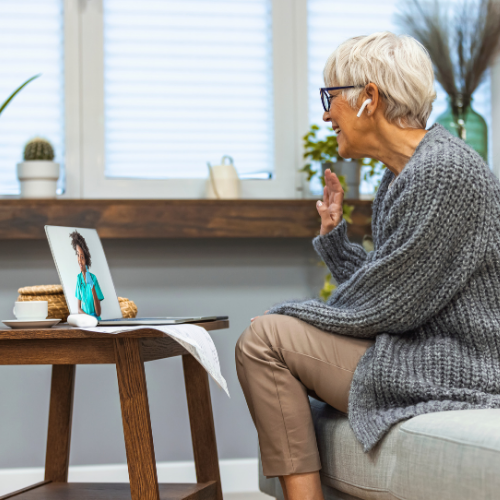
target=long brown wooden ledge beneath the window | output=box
[0,199,372,241]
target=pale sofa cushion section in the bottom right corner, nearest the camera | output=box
[390,410,500,500]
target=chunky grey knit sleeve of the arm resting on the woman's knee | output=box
[269,154,492,338]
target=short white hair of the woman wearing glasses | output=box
[323,31,436,129]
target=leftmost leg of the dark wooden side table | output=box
[45,365,75,483]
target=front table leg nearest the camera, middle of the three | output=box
[115,338,160,500]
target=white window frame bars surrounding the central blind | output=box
[62,0,500,199]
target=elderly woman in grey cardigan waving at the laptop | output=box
[236,32,500,500]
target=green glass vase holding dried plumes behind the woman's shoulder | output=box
[436,96,488,162]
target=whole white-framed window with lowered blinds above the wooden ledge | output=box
[0,0,500,199]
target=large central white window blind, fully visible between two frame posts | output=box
[104,0,274,179]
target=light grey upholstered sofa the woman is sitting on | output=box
[310,398,500,500]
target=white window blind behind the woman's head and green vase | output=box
[308,0,491,194]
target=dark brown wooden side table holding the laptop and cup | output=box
[0,321,229,500]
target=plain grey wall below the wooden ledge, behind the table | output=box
[0,239,324,468]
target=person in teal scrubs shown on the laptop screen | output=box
[69,231,104,320]
